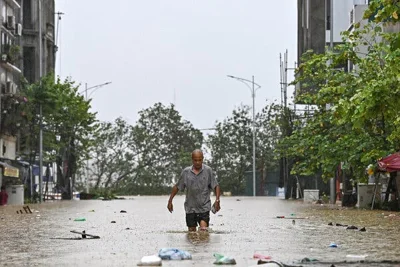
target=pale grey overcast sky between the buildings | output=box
[56,0,297,133]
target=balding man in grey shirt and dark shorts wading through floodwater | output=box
[167,149,221,232]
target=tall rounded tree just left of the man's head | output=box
[131,103,203,193]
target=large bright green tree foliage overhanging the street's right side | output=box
[280,10,400,182]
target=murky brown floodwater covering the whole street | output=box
[0,196,400,267]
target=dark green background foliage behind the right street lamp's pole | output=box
[207,104,281,195]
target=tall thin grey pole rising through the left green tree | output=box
[38,0,43,203]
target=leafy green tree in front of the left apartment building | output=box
[21,74,95,198]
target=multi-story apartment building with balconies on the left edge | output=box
[0,0,56,188]
